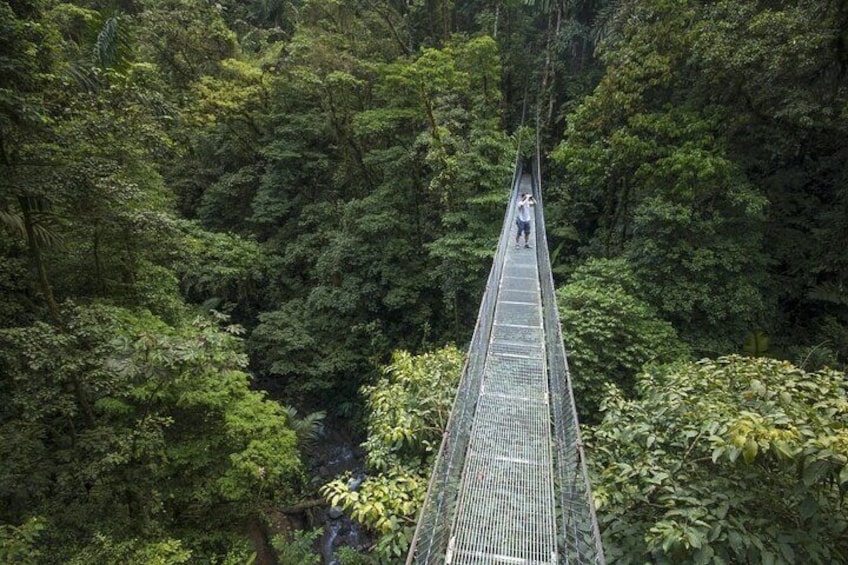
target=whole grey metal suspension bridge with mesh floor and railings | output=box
[406,152,605,565]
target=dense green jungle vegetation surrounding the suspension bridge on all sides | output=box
[0,0,848,565]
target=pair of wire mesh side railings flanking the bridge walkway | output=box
[406,119,605,565]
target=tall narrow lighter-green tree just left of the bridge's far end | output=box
[378,37,514,338]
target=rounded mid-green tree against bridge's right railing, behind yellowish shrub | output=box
[557,259,688,423]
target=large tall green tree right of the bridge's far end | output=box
[553,1,770,351]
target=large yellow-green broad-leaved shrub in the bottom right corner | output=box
[587,357,848,564]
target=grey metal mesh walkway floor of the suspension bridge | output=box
[445,213,557,564]
